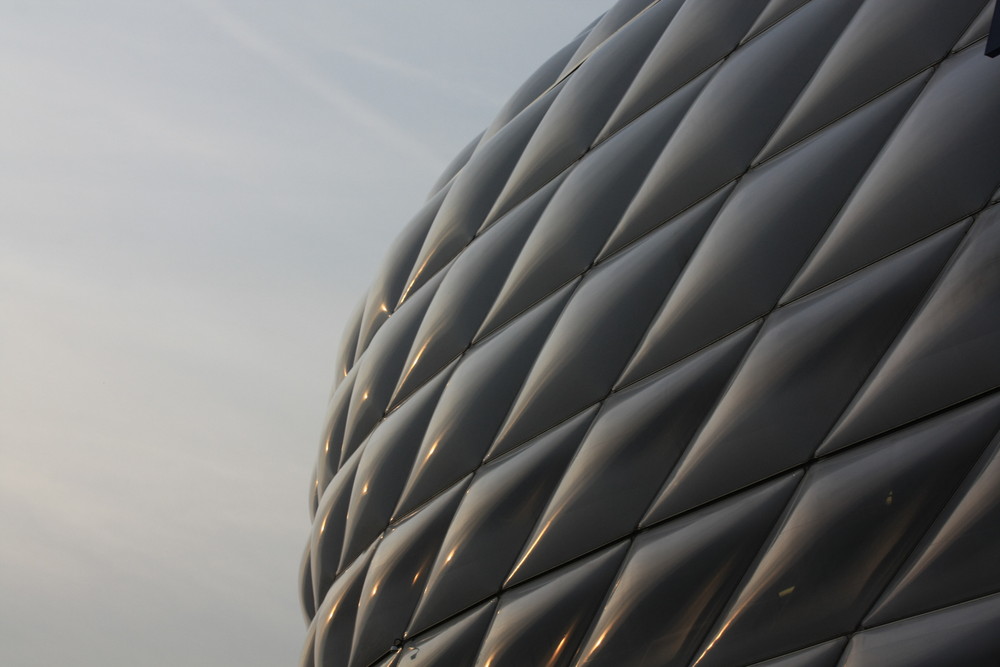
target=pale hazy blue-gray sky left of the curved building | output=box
[0,0,612,667]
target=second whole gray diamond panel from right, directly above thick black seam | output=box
[510,328,756,582]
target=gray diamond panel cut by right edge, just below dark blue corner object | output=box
[784,49,1000,301]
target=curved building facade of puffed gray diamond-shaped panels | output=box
[302,0,1000,667]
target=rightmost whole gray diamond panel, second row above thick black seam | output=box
[625,76,922,386]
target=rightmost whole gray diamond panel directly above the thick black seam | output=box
[650,228,962,520]
